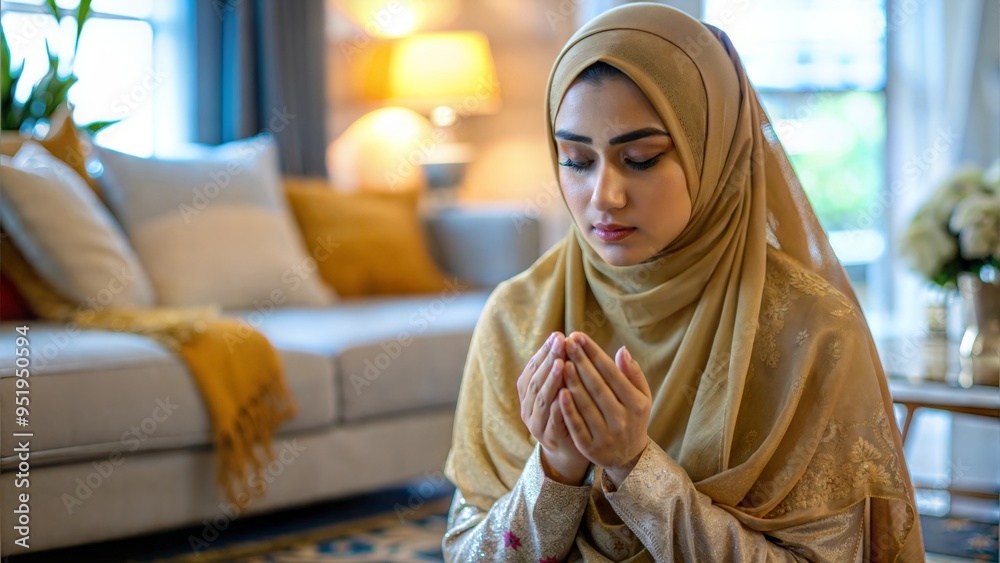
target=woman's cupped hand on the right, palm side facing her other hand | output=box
[559,332,652,486]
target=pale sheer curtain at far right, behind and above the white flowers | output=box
[887,0,1000,337]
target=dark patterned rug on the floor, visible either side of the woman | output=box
[5,479,997,563]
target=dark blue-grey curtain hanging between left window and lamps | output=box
[192,0,327,176]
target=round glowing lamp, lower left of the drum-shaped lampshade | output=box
[327,107,433,192]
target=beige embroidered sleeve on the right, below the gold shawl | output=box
[602,441,866,561]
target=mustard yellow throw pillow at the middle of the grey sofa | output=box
[285,178,446,297]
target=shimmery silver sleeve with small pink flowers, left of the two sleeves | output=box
[442,446,593,563]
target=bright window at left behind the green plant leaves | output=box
[2,0,190,156]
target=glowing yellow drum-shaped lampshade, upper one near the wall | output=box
[387,31,500,120]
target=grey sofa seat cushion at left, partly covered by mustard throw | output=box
[0,322,339,469]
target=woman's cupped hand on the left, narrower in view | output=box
[517,332,590,485]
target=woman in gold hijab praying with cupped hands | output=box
[444,4,923,562]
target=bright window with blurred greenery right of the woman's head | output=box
[704,0,889,321]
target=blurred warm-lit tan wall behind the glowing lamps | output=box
[327,0,701,246]
